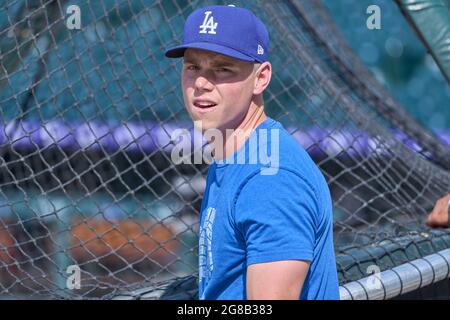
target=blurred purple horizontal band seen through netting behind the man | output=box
[0,121,450,156]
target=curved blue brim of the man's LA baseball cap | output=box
[166,42,257,62]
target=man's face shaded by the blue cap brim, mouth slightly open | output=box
[181,49,257,131]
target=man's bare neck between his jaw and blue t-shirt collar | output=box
[212,103,267,160]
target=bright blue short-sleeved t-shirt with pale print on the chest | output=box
[199,118,339,300]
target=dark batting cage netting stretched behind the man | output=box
[0,0,450,299]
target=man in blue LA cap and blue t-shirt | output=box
[166,6,339,299]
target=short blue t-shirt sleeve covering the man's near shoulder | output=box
[234,169,320,265]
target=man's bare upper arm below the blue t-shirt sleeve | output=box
[246,260,310,300]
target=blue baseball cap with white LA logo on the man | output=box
[166,5,269,63]
